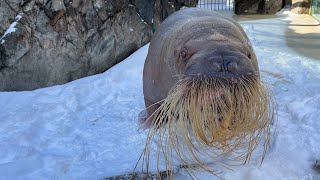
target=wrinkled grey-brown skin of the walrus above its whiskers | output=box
[143,8,259,127]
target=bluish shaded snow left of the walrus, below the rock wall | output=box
[0,46,148,179]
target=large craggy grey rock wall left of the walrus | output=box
[0,0,197,91]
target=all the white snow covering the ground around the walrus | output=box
[0,8,320,180]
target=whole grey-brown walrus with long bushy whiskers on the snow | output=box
[143,8,274,179]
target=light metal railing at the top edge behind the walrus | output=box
[198,0,234,11]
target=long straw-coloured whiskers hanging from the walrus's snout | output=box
[143,75,274,177]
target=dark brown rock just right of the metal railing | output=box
[235,0,283,15]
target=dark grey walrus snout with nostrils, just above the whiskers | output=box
[184,52,255,77]
